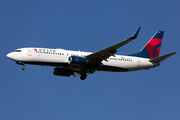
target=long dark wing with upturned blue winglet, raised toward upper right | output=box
[86,27,140,66]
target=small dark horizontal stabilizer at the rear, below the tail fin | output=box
[150,52,177,63]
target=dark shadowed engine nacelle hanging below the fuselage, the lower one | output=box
[53,68,73,77]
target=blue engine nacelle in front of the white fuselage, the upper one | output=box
[68,56,87,64]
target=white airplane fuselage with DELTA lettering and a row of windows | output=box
[7,48,157,72]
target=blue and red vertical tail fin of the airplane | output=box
[131,31,164,59]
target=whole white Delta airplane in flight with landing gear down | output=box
[7,27,177,80]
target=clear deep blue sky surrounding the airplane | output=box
[0,0,180,120]
